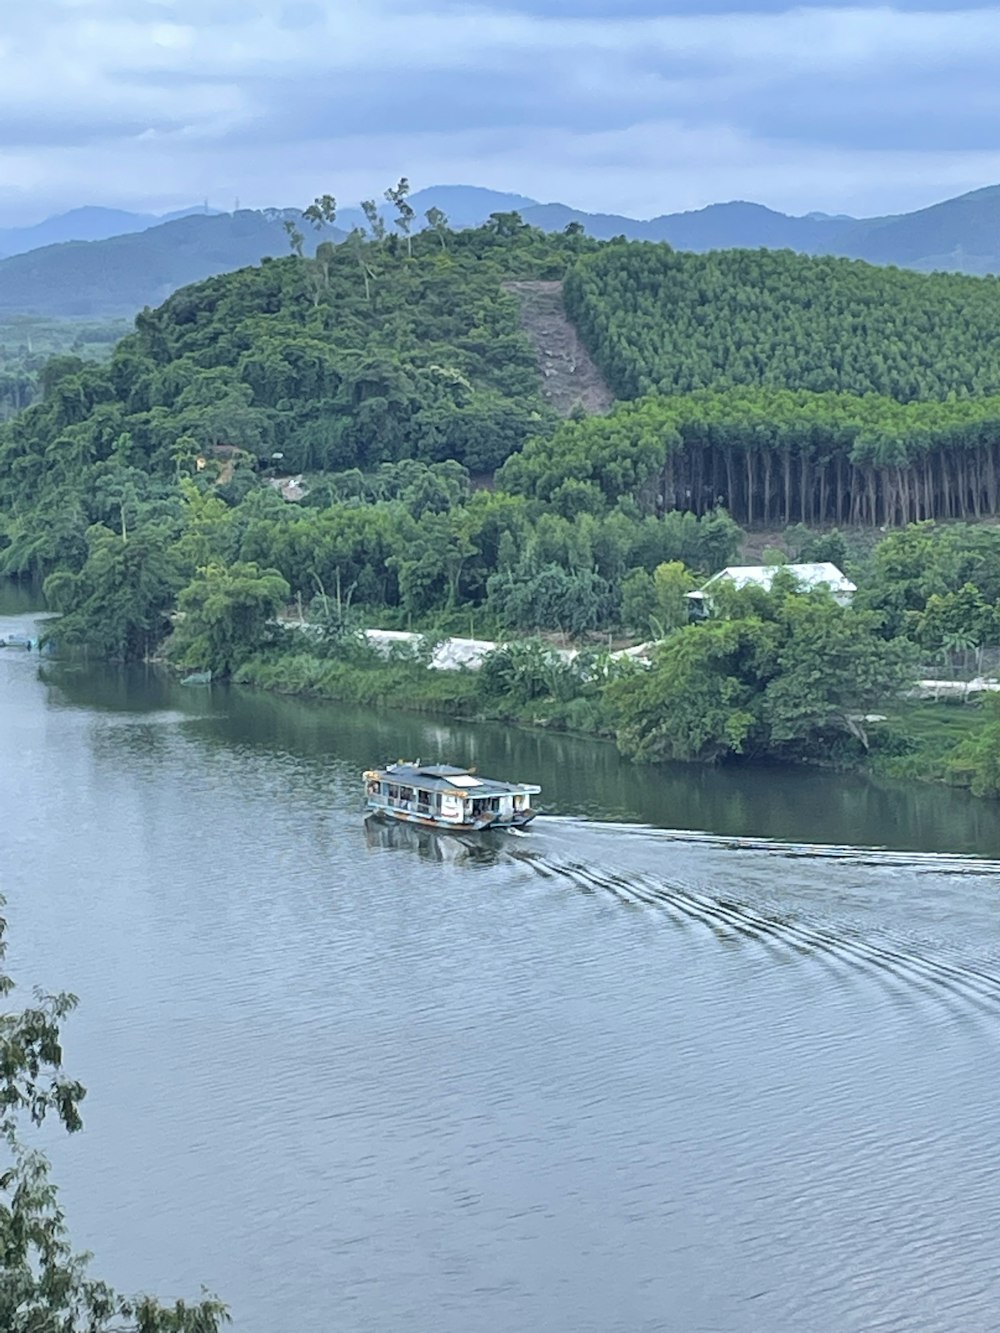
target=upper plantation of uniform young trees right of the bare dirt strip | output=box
[565,244,1000,403]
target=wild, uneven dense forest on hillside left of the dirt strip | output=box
[0,217,592,575]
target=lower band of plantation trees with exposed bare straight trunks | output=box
[500,389,1000,525]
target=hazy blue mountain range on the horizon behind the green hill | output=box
[0,185,1000,317]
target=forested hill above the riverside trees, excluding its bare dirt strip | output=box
[9,213,1000,589]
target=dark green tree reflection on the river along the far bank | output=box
[31,663,1000,856]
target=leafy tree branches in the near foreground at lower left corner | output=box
[0,898,229,1333]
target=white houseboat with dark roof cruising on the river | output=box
[364,760,541,833]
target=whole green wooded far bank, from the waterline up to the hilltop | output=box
[0,193,1000,796]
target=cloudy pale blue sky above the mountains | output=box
[0,0,1000,225]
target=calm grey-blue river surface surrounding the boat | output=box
[0,616,1000,1333]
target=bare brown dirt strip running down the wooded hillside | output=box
[504,283,615,416]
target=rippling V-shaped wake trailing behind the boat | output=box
[365,817,1000,1013]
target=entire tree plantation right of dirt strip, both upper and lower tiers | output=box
[565,244,1000,525]
